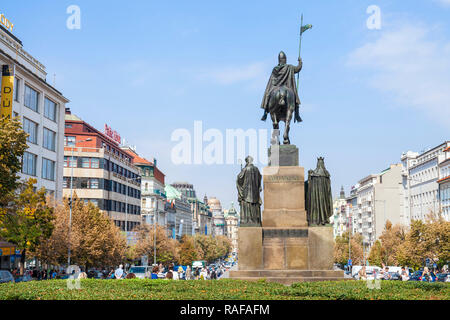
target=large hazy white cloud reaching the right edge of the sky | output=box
[349,26,450,125]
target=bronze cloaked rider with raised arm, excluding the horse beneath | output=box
[261,51,303,122]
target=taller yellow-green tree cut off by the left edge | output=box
[0,117,28,206]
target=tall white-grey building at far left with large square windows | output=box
[0,22,69,199]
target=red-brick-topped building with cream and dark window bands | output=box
[63,109,141,231]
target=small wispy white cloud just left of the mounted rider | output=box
[200,62,269,85]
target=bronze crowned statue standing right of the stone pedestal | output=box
[305,157,333,225]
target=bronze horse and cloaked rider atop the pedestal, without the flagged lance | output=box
[261,51,302,144]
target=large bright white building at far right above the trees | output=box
[402,141,450,225]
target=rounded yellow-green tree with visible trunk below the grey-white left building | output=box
[0,179,54,274]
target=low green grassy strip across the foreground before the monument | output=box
[0,279,450,300]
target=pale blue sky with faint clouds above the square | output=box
[0,0,450,209]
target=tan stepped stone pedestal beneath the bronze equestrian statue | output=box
[230,145,344,284]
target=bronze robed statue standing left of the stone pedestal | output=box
[236,156,262,227]
